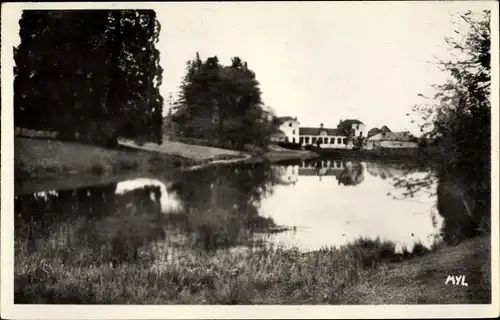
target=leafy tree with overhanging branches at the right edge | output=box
[407,10,491,242]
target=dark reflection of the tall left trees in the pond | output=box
[15,184,163,263]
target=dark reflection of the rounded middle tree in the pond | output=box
[169,164,279,250]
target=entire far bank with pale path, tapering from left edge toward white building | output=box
[14,137,317,195]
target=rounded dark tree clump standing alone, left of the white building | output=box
[172,53,278,149]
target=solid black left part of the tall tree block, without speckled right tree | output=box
[14,10,107,136]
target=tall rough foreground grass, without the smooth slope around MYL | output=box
[15,225,470,304]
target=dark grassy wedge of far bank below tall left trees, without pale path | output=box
[14,138,193,193]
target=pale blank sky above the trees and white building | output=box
[5,1,492,134]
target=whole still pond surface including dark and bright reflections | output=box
[15,160,443,261]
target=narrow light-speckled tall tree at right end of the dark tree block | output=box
[112,10,163,143]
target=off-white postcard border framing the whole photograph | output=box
[0,1,500,319]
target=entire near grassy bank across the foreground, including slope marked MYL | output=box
[14,232,490,304]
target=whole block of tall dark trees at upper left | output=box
[14,10,163,146]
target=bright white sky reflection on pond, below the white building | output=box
[261,160,442,250]
